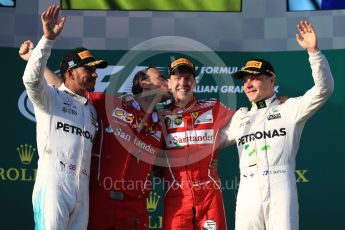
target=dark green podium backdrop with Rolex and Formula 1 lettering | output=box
[0,48,345,229]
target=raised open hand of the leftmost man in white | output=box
[41,5,66,40]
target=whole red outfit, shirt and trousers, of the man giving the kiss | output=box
[88,93,163,230]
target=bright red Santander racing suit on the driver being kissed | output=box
[163,98,235,230]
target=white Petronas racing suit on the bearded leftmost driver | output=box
[23,37,97,230]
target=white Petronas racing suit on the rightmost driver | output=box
[225,51,333,230]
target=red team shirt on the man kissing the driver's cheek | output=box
[89,93,162,198]
